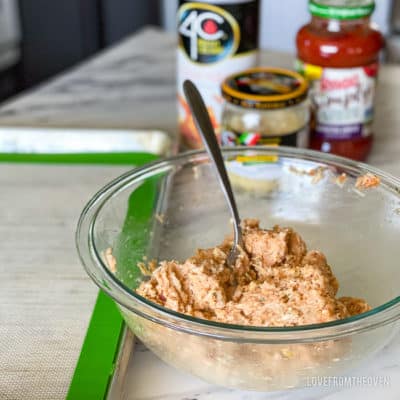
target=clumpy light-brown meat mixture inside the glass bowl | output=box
[137,219,369,326]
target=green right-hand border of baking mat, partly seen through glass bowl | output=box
[67,155,163,400]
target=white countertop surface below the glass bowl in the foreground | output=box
[107,330,400,400]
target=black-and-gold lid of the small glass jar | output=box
[221,68,308,109]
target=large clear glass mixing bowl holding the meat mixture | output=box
[76,147,400,391]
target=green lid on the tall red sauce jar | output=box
[308,0,375,19]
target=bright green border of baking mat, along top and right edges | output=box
[0,132,169,400]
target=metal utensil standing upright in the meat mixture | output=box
[183,80,243,266]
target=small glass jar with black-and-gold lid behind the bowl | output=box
[220,68,309,147]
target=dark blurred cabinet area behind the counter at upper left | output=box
[0,0,160,100]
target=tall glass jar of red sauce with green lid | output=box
[296,0,384,160]
